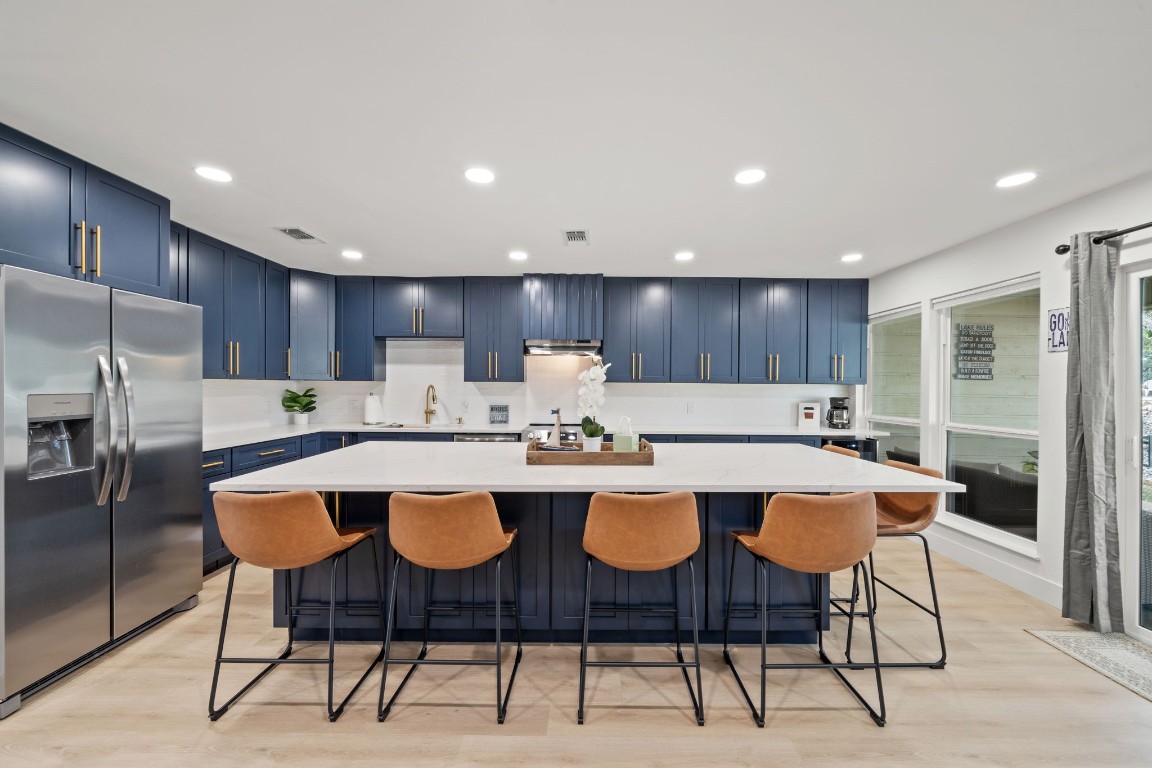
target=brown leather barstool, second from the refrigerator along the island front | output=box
[377,491,524,723]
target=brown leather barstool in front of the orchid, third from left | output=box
[576,491,704,725]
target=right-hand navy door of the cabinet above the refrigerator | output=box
[84,166,169,297]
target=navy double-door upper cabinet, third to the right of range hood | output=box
[740,279,809,383]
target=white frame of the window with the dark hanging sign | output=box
[930,273,1041,562]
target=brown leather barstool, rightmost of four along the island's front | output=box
[723,491,886,728]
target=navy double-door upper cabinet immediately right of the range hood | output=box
[604,277,672,382]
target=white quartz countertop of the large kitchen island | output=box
[211,442,964,493]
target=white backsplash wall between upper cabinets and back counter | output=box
[204,339,863,432]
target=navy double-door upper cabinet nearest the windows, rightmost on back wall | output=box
[808,280,867,385]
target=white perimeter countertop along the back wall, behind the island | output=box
[204,421,888,450]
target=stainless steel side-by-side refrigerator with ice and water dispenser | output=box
[0,266,203,717]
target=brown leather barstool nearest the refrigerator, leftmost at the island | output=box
[209,491,384,721]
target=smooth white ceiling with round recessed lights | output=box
[0,0,1152,276]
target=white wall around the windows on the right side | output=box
[869,169,1152,606]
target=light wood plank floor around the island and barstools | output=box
[0,541,1152,768]
